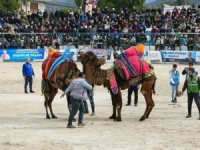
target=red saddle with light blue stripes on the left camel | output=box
[42,49,77,89]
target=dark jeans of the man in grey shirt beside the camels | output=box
[68,97,85,125]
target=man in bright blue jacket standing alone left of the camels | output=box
[22,58,35,93]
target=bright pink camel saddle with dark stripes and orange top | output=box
[114,44,154,85]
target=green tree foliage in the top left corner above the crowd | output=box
[0,0,20,11]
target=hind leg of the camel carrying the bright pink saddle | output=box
[140,81,154,121]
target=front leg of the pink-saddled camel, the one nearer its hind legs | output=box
[115,91,122,121]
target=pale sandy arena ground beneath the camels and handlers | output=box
[0,62,200,150]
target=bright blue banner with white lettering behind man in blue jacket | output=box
[0,49,45,61]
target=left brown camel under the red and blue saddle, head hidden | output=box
[41,61,80,119]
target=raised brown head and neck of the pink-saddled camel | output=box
[79,51,105,86]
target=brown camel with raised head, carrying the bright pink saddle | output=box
[79,51,156,121]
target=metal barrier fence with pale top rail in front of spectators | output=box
[0,32,200,50]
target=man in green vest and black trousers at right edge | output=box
[182,69,200,120]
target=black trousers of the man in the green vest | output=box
[188,93,200,115]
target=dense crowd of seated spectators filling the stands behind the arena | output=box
[0,7,200,50]
